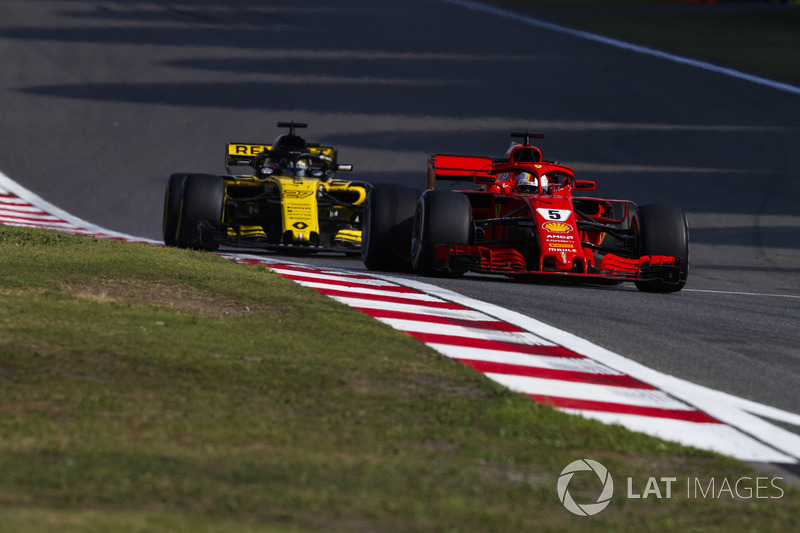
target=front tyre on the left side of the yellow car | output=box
[176,174,225,252]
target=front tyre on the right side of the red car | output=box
[632,204,689,292]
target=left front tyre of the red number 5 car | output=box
[411,190,472,277]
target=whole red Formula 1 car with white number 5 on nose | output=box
[362,131,689,292]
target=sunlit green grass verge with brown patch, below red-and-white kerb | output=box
[0,227,800,533]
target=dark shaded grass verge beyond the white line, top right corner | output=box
[491,0,800,86]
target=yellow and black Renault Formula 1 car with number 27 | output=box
[163,122,370,253]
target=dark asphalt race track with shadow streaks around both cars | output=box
[0,0,800,440]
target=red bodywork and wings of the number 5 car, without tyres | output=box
[428,144,680,281]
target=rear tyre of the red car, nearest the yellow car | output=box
[361,184,420,271]
